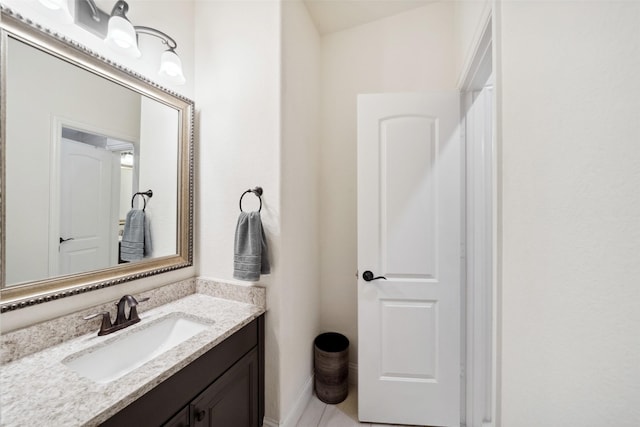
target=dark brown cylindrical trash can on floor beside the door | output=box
[313,332,349,404]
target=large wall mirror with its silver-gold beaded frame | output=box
[0,8,193,312]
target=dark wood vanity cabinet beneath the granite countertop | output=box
[103,315,264,427]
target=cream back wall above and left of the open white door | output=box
[320,3,456,363]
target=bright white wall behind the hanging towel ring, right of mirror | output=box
[195,1,282,420]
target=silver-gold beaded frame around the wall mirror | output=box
[0,5,194,313]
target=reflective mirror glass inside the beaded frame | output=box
[5,38,178,286]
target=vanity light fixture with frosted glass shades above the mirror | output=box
[74,0,186,85]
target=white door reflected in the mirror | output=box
[58,138,120,274]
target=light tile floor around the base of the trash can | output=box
[296,385,424,427]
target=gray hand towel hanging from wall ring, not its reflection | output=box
[233,212,271,282]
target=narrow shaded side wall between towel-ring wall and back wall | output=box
[279,0,320,425]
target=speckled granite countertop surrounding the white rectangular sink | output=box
[0,294,264,426]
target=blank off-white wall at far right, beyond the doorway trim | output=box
[496,1,640,427]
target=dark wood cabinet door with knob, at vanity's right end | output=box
[191,349,262,427]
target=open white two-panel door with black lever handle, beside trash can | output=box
[358,91,462,426]
